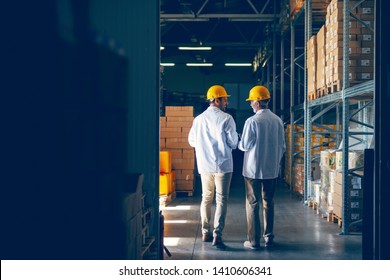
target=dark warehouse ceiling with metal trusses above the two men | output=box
[160,0,280,65]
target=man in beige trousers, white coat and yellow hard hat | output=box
[188,85,238,249]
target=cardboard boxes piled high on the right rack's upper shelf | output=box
[307,0,374,100]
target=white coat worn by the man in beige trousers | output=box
[188,106,238,174]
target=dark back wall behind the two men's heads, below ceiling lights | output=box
[161,65,256,131]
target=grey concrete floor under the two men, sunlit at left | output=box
[161,175,362,260]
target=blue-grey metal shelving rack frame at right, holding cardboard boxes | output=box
[281,0,374,234]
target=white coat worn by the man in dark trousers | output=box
[238,109,286,179]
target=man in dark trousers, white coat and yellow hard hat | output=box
[238,86,286,249]
